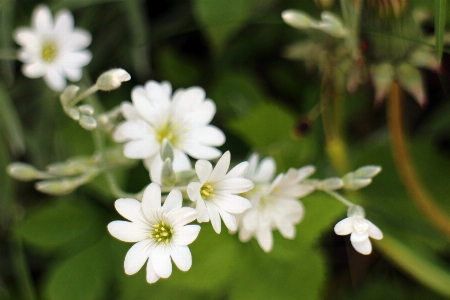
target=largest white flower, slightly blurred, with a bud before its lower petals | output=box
[114,81,225,179]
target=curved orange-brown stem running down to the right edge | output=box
[387,82,450,239]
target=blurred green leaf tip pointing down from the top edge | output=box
[194,0,254,51]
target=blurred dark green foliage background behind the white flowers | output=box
[0,0,450,300]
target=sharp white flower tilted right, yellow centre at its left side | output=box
[187,151,253,233]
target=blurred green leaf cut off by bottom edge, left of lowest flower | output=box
[44,238,110,300]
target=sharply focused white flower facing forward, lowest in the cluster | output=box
[108,183,200,283]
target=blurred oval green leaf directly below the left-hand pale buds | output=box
[18,198,98,251]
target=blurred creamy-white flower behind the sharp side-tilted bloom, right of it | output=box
[239,155,315,252]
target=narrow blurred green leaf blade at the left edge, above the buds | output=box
[0,82,25,155]
